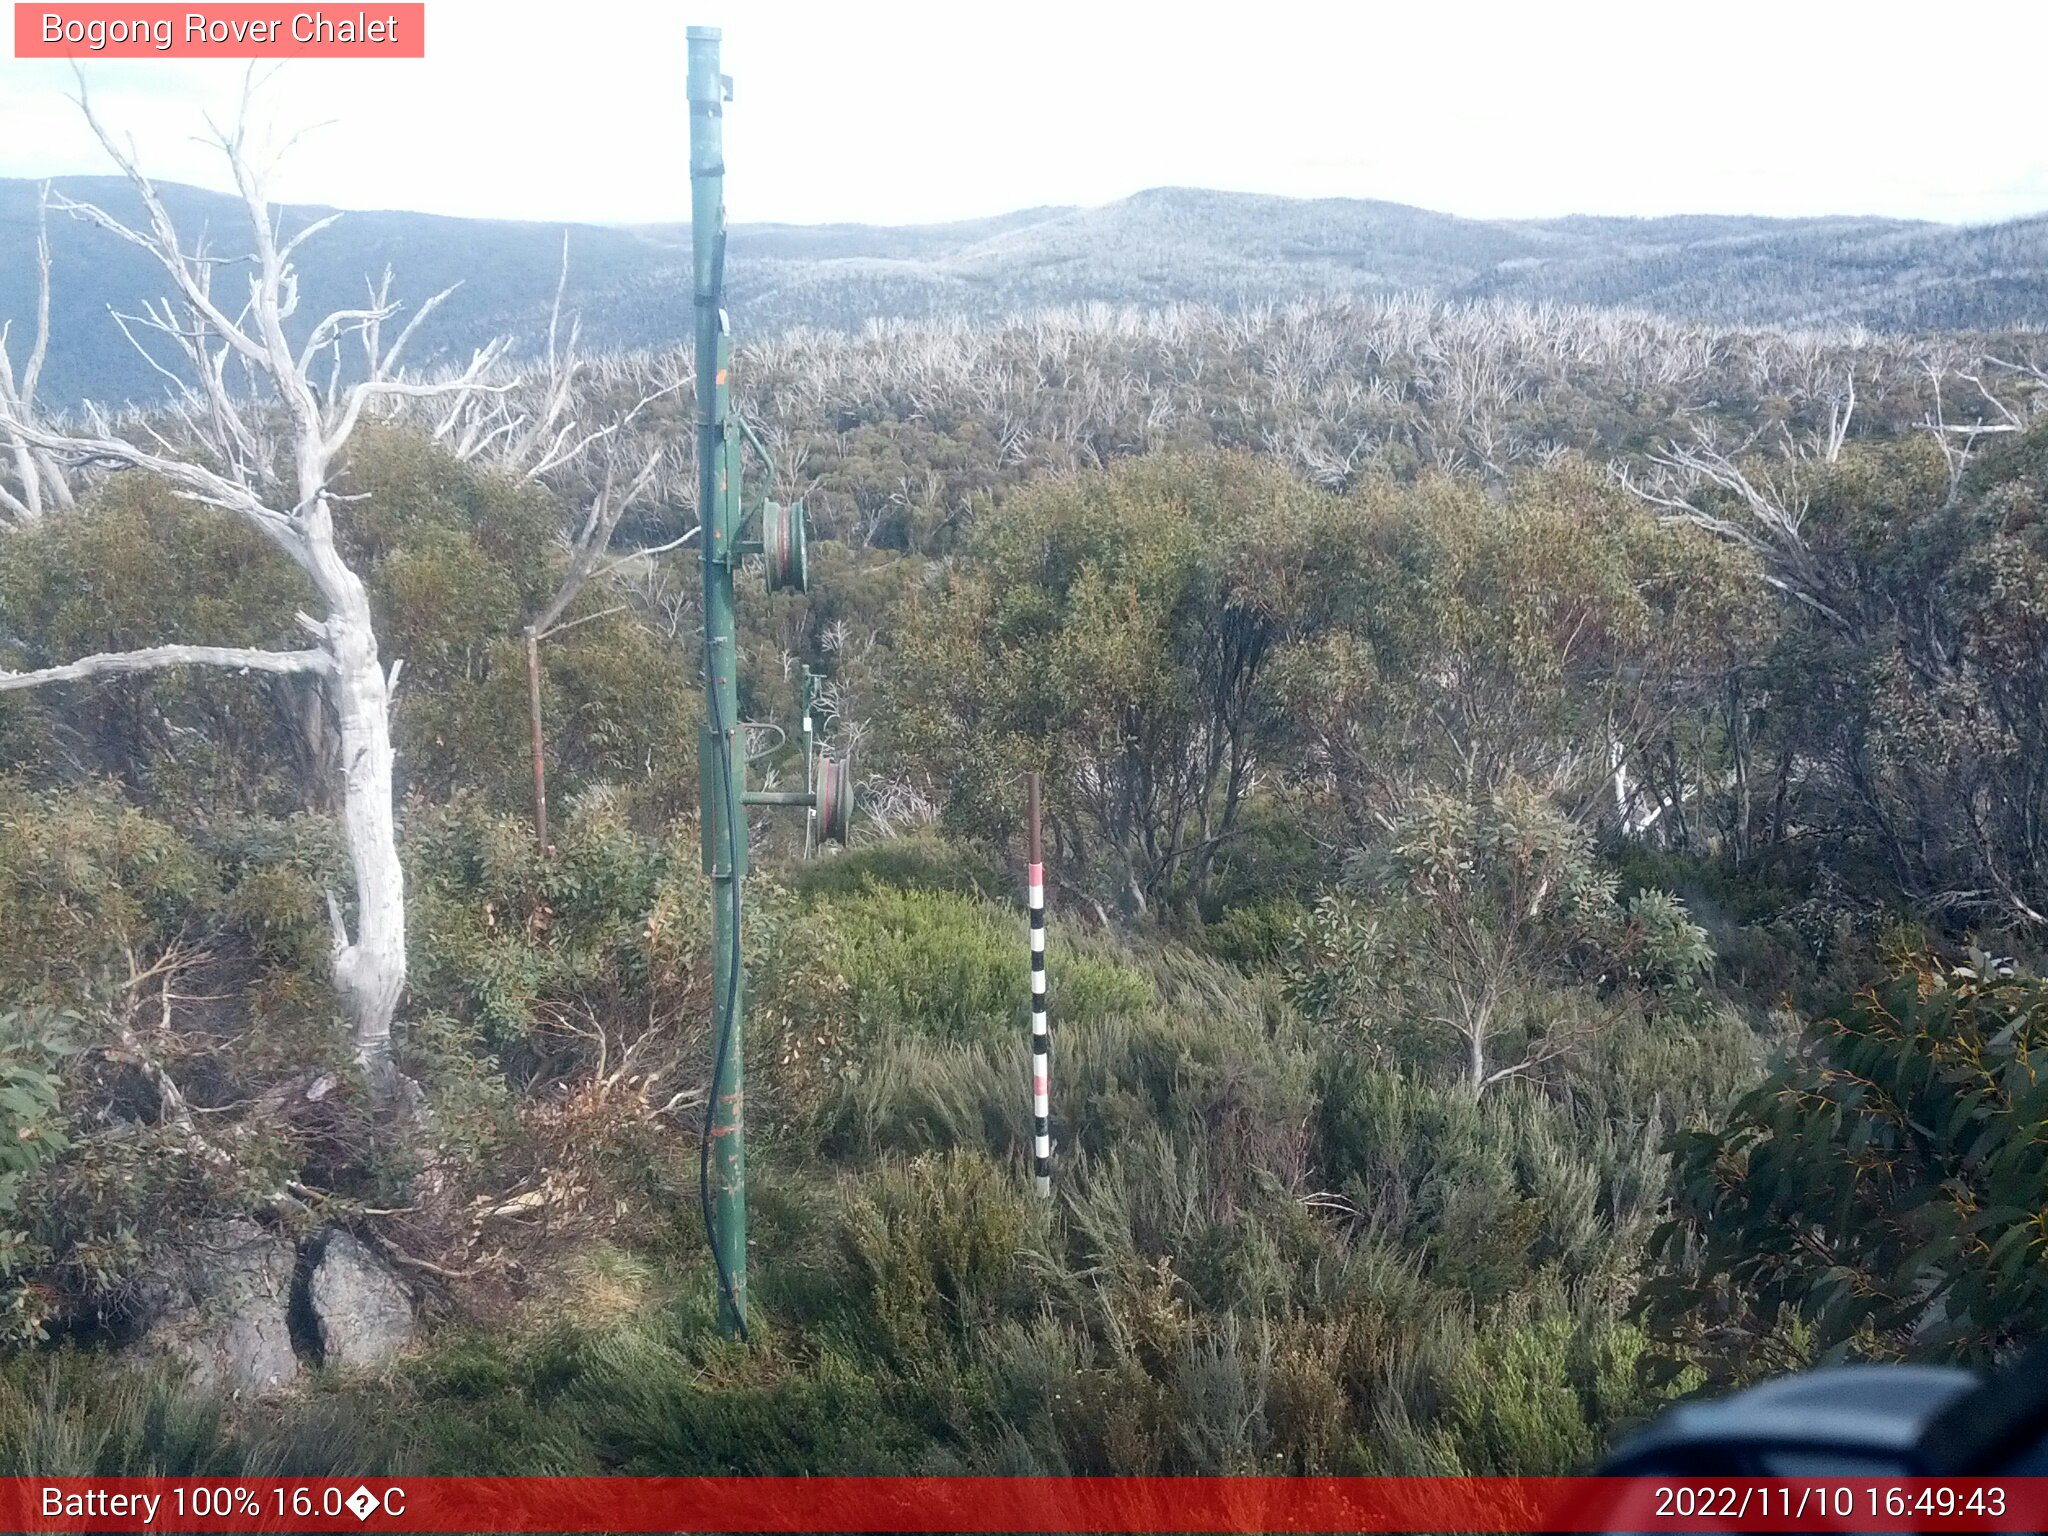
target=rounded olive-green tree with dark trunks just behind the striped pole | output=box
[895,455,1356,911]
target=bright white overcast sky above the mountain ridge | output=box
[0,0,2048,223]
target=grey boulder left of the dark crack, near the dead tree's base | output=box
[141,1217,299,1393]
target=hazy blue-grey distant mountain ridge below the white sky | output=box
[0,178,2048,406]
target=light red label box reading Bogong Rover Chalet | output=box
[14,0,426,59]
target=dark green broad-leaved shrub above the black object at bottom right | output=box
[1645,956,2048,1372]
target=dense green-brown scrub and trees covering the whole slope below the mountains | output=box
[0,294,2048,1473]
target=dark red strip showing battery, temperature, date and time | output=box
[0,1477,2048,1532]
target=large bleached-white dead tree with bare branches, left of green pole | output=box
[0,92,502,1094]
